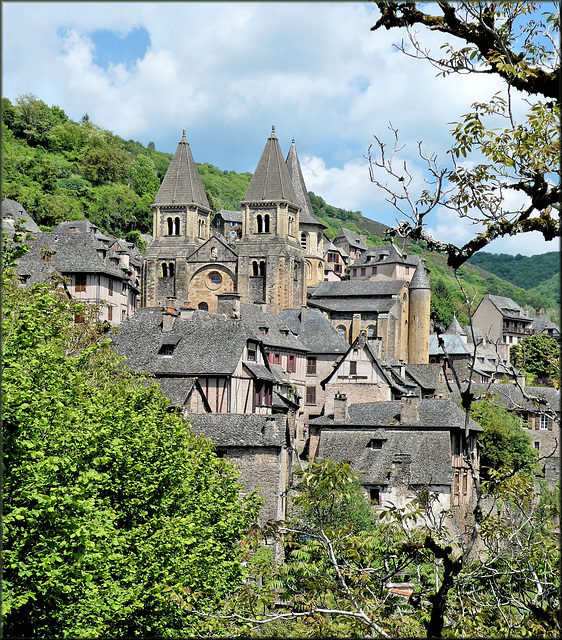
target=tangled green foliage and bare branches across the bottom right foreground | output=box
[176,460,560,638]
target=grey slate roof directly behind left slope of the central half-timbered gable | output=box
[279,309,349,354]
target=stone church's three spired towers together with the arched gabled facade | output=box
[141,127,325,313]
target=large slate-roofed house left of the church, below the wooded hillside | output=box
[16,220,141,325]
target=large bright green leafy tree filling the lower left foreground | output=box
[2,262,258,638]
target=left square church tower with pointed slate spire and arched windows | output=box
[141,130,212,307]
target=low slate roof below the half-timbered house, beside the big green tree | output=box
[189,413,287,448]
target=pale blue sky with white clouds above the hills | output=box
[2,1,559,255]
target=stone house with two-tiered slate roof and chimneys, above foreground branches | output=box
[310,394,482,511]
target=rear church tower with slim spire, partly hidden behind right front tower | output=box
[286,140,327,287]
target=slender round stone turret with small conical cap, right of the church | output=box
[407,260,431,364]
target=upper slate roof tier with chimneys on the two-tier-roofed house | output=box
[310,398,483,431]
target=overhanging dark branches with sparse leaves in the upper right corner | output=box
[368,1,560,268]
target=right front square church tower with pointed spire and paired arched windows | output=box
[236,127,306,313]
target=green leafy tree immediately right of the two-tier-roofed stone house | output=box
[470,398,537,477]
